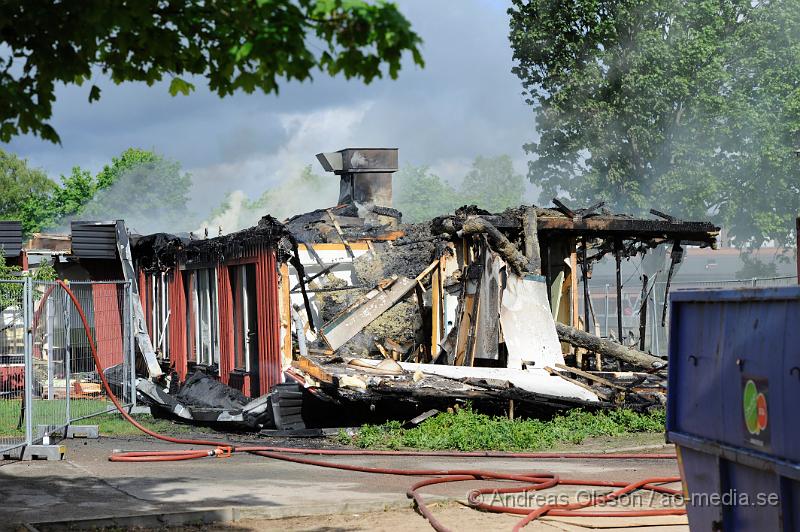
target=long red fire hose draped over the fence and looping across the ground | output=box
[58,280,686,532]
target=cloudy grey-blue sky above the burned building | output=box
[3,0,534,216]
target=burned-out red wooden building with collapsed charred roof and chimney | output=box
[6,148,718,426]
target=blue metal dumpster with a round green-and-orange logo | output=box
[667,287,800,531]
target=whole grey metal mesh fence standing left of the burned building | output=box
[0,278,135,454]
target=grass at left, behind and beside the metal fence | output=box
[0,399,212,438]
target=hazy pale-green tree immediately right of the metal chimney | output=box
[393,165,463,222]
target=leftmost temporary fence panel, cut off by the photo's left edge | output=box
[0,279,29,453]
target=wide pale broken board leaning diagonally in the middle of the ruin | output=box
[320,277,417,351]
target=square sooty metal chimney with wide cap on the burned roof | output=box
[317,148,397,207]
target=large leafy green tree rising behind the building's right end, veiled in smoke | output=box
[509,0,800,246]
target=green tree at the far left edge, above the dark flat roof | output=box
[0,149,57,232]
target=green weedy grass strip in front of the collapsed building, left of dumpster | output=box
[338,406,666,451]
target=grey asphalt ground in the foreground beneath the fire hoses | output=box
[0,435,685,530]
